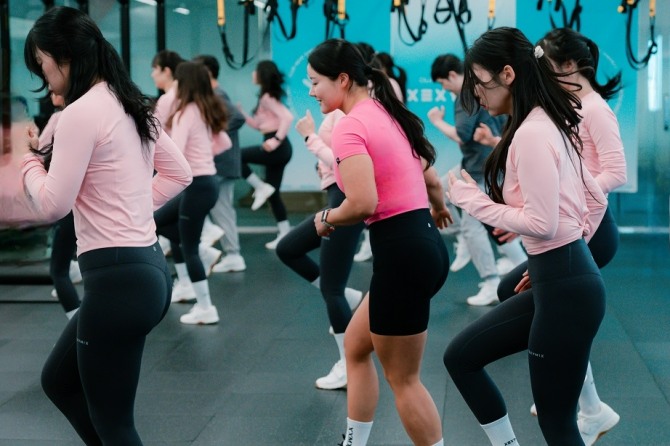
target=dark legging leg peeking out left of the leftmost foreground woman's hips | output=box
[49,212,81,312]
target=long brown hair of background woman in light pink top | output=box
[168,62,228,133]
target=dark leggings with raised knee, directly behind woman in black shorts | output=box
[277,184,365,333]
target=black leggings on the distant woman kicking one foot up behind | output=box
[242,132,293,221]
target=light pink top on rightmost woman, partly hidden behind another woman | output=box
[579,91,626,195]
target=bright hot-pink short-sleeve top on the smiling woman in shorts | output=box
[332,99,428,225]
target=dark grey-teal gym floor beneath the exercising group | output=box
[0,210,670,446]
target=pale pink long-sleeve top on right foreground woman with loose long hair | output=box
[450,107,607,254]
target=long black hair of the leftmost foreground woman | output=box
[23,6,160,158]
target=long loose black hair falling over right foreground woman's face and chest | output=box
[461,27,582,203]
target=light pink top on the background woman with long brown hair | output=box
[171,102,216,177]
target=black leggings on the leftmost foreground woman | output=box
[42,243,172,446]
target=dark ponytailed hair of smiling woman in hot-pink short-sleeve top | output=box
[307,39,436,166]
